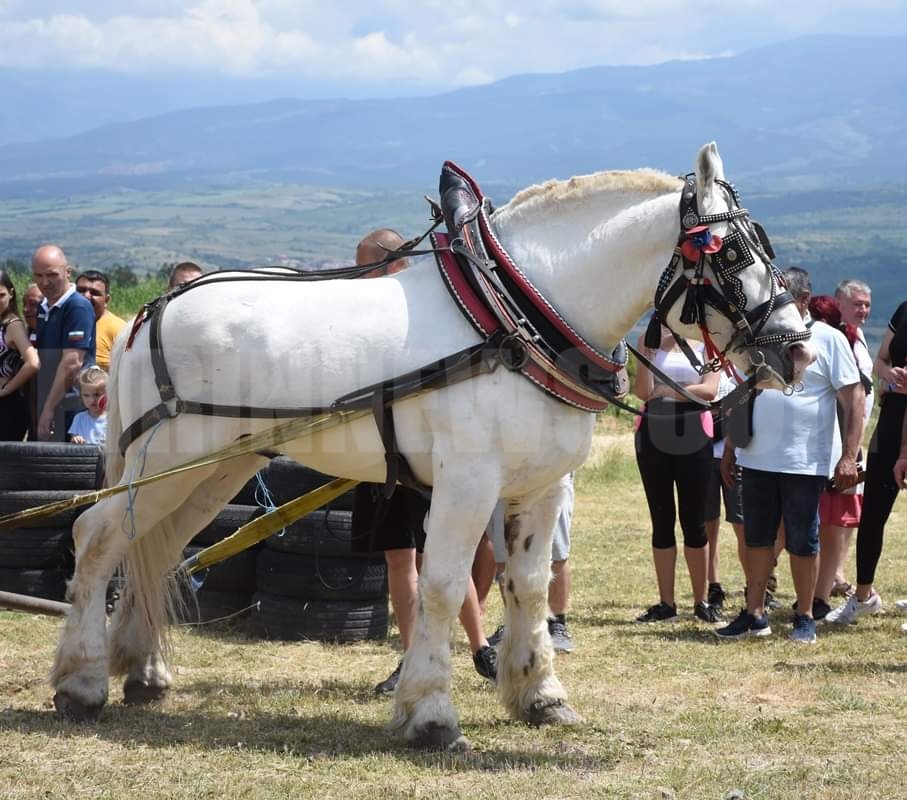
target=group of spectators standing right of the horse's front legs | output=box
[635,267,907,644]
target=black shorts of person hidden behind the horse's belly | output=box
[351,483,430,553]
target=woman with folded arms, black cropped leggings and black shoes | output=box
[634,327,721,622]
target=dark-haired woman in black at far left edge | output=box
[0,269,40,442]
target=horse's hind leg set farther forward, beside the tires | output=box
[110,455,267,704]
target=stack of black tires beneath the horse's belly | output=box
[249,458,388,642]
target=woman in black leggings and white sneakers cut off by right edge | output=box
[829,302,907,623]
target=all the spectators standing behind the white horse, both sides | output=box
[0,234,907,694]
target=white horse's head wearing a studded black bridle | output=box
[655,142,814,388]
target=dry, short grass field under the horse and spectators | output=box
[0,418,907,800]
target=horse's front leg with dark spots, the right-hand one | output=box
[498,478,579,725]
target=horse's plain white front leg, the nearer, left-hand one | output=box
[391,463,497,750]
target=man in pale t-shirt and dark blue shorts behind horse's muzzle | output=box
[715,267,865,644]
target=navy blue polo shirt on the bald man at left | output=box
[37,286,95,400]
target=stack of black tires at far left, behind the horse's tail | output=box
[0,442,103,600]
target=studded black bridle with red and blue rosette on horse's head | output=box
[646,174,810,384]
